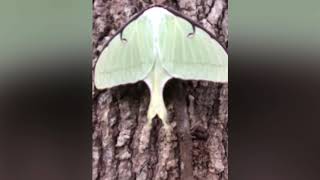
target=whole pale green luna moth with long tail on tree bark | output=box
[94,6,228,128]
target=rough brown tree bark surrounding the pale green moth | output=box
[92,0,228,180]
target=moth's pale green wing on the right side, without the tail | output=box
[159,14,228,82]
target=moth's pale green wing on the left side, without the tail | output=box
[94,17,154,89]
